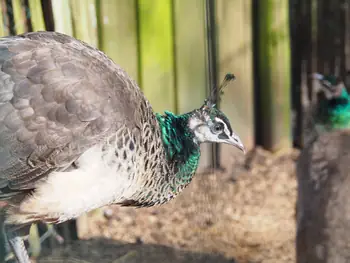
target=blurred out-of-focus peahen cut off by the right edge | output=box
[296,74,350,263]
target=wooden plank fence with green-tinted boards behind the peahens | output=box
[0,0,350,262]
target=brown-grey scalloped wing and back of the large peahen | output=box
[0,32,144,200]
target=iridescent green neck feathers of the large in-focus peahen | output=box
[156,111,200,188]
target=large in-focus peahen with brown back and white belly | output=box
[0,32,244,263]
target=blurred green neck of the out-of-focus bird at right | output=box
[317,88,350,130]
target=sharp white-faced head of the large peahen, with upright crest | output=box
[189,74,245,153]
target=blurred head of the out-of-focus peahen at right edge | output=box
[312,73,347,101]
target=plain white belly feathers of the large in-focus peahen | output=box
[16,147,140,224]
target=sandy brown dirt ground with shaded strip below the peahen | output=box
[39,148,298,263]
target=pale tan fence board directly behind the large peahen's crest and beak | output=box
[216,0,255,162]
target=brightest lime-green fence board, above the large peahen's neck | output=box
[138,0,177,113]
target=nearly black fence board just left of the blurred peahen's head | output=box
[290,0,316,148]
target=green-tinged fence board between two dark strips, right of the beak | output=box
[256,0,292,151]
